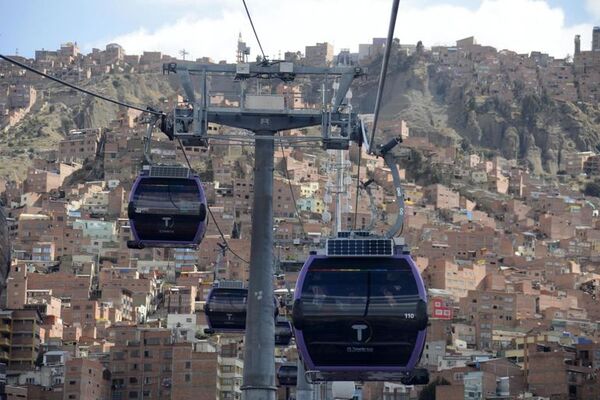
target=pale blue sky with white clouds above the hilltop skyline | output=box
[0,0,600,62]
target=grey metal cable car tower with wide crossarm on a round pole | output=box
[161,62,364,400]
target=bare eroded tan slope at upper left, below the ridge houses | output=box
[0,74,178,179]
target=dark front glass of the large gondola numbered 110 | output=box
[299,258,426,366]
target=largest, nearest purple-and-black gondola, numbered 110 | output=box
[293,238,428,383]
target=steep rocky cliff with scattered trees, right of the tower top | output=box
[356,49,600,174]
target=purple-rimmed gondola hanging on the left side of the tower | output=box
[127,165,207,249]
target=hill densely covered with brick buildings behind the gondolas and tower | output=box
[0,30,600,400]
